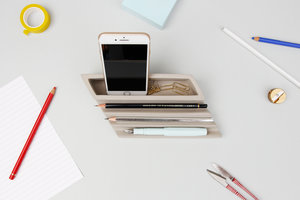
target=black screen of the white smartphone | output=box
[102,44,148,91]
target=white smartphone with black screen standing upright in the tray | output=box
[98,33,150,95]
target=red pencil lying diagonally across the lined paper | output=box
[9,87,56,180]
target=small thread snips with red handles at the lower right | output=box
[207,163,258,200]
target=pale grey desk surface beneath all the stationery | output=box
[0,0,300,200]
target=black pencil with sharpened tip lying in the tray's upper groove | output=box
[96,103,207,108]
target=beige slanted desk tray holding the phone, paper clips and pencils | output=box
[82,74,221,138]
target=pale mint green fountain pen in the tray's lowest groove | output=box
[125,128,207,136]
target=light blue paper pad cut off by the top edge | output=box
[122,0,177,29]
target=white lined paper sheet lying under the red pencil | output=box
[0,77,82,200]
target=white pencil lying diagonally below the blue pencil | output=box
[221,27,300,88]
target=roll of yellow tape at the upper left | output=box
[20,4,50,35]
